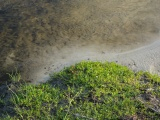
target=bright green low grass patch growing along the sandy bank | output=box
[0,62,160,120]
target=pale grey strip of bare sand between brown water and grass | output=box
[27,40,160,83]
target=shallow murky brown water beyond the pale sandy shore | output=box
[0,0,160,81]
